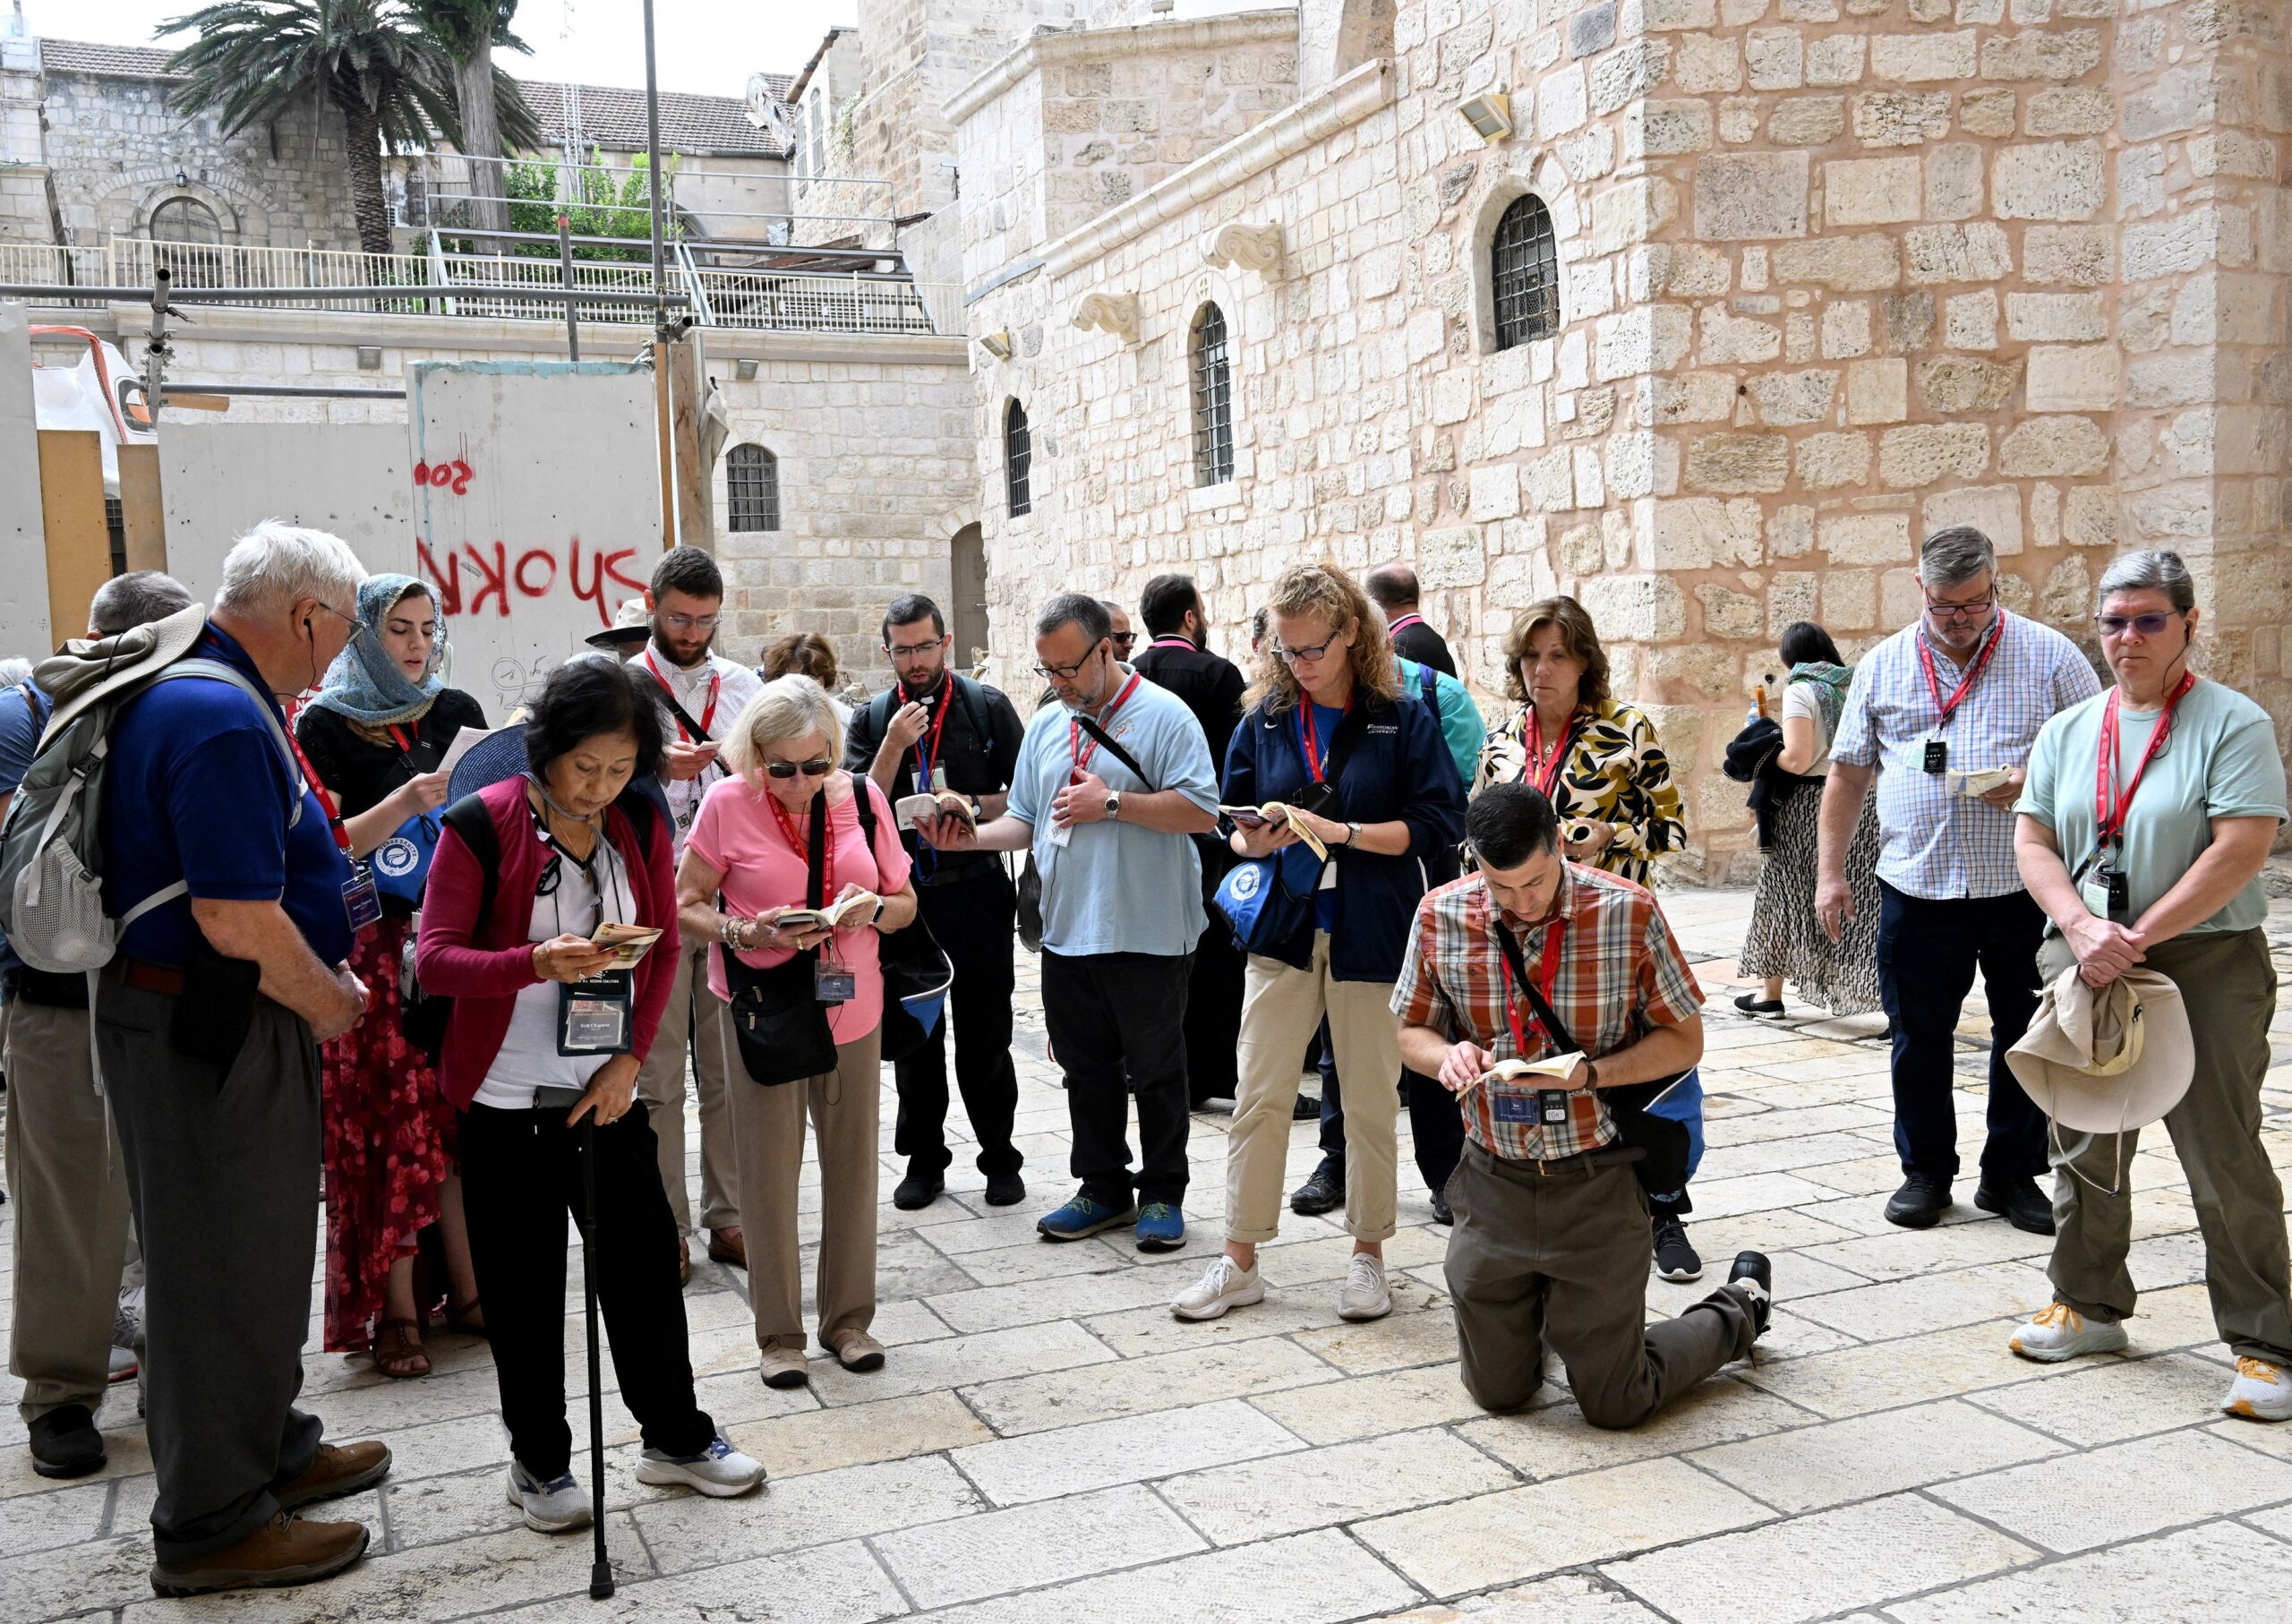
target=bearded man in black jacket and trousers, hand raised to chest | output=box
[843,594,1027,1211]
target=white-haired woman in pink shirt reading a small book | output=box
[676,676,914,1388]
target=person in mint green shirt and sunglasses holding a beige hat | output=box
[2013,550,2292,1420]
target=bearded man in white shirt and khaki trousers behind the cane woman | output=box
[630,547,763,1274]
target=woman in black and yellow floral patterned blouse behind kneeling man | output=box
[1474,598,1687,885]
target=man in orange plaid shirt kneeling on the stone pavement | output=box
[1393,783,1772,1427]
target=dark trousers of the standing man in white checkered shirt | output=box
[1877,879,2047,1180]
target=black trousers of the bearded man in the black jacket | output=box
[892,864,1024,1177]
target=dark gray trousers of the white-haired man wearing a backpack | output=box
[97,973,323,1564]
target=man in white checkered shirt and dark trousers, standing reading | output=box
[1816,525,2102,1235]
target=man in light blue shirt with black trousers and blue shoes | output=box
[924,594,1217,1251]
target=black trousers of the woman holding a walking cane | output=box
[461,1094,714,1482]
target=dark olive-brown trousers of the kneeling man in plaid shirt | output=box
[1449,1141,1753,1427]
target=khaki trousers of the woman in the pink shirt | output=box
[720,1021,883,1349]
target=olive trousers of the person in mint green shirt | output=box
[2040,930,2292,1367]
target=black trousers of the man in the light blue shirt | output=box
[1043,948,1192,1211]
